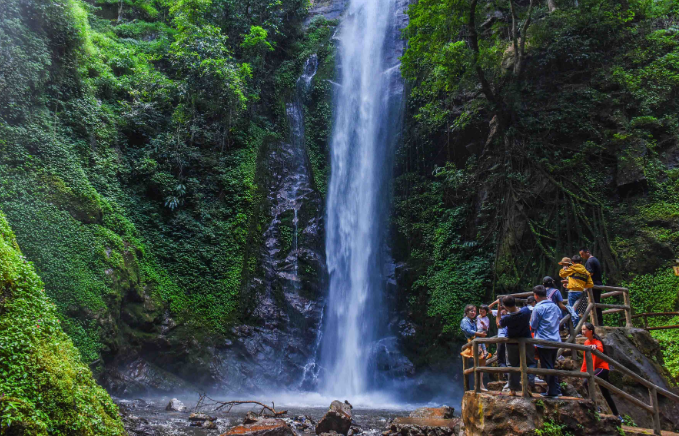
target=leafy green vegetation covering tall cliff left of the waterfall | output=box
[0,0,334,374]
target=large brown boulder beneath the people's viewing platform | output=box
[462,391,620,436]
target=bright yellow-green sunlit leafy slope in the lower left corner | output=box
[0,209,126,436]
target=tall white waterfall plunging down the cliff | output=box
[321,0,406,396]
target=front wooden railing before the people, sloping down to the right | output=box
[462,337,679,435]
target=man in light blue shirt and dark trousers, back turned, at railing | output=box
[530,285,561,397]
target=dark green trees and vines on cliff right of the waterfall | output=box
[393,0,679,350]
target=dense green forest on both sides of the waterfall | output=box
[0,0,679,434]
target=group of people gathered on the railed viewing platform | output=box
[460,248,618,415]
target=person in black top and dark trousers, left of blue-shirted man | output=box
[497,295,535,396]
